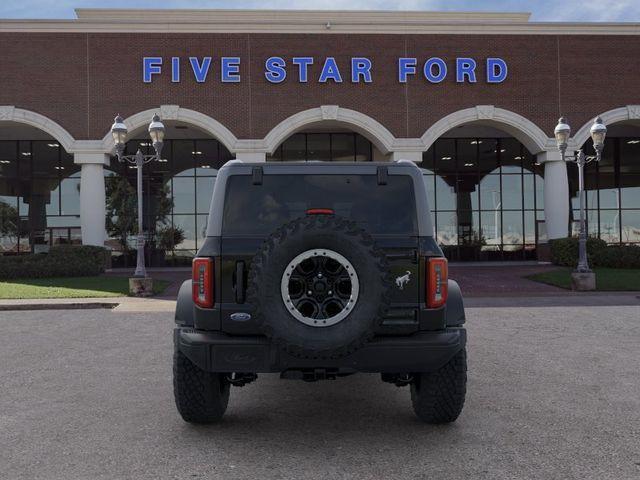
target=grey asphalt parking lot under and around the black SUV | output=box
[0,306,640,480]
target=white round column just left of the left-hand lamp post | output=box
[74,152,109,247]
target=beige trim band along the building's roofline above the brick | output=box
[0,9,640,35]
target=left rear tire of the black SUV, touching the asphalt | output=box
[173,348,229,423]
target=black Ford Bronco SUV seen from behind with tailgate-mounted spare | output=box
[173,160,467,423]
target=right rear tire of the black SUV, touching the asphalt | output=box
[411,348,467,424]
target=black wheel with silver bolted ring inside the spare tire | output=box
[280,248,360,327]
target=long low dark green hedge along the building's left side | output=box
[0,245,108,280]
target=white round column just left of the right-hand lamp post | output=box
[537,151,569,240]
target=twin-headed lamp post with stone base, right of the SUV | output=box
[554,117,607,290]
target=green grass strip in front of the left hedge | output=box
[0,276,169,299]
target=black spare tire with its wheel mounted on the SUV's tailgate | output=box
[247,215,390,358]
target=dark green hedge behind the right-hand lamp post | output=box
[549,237,640,268]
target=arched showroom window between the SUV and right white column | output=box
[421,138,544,260]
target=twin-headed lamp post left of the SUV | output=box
[111,114,165,284]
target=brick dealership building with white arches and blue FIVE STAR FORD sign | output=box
[0,9,640,265]
